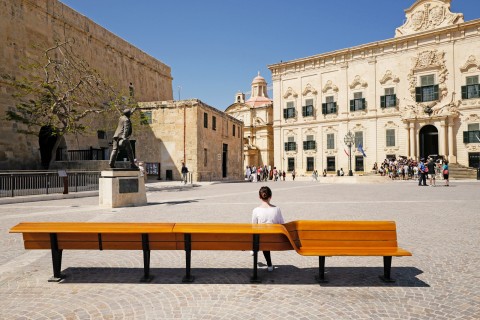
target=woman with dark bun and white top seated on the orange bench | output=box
[252,187,285,272]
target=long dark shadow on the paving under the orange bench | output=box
[61,265,430,287]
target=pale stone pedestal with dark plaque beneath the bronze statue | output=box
[99,169,147,208]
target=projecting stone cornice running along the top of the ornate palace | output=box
[267,19,480,77]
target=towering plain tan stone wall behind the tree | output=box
[0,0,173,169]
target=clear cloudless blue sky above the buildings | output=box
[61,0,480,110]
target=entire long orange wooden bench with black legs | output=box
[10,221,411,282]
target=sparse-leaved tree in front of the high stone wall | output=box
[2,39,125,168]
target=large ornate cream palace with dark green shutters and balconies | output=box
[269,0,480,174]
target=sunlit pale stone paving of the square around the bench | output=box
[0,178,480,320]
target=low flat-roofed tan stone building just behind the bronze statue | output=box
[135,99,243,181]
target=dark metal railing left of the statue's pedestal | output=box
[0,171,100,198]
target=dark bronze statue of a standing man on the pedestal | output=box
[110,109,138,169]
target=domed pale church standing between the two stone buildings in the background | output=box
[225,72,274,167]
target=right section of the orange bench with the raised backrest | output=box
[285,221,412,282]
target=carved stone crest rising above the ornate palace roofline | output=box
[395,0,464,38]
